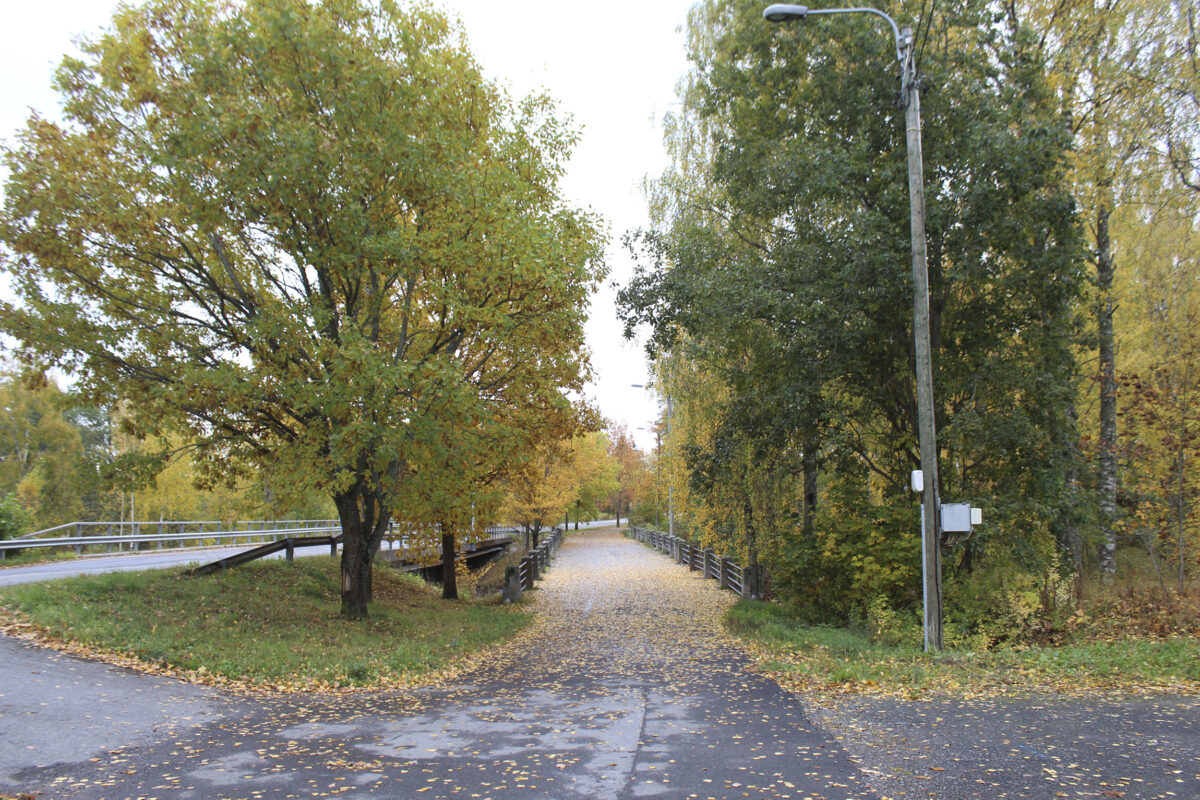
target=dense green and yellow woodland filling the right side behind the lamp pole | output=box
[620,0,1200,646]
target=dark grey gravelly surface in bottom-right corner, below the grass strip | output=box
[810,694,1200,800]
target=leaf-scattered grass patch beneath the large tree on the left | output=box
[0,558,530,691]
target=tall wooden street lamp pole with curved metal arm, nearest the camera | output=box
[762,4,942,650]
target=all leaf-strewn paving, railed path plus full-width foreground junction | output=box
[0,531,1200,800]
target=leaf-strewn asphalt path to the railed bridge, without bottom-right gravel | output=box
[0,531,880,800]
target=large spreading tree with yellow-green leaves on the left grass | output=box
[0,0,602,618]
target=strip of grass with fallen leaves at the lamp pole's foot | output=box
[726,600,1200,698]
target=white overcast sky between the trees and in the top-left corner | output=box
[0,0,694,449]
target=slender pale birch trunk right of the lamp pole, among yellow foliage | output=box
[1096,205,1117,577]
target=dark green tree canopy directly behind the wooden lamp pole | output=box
[622,0,1084,615]
